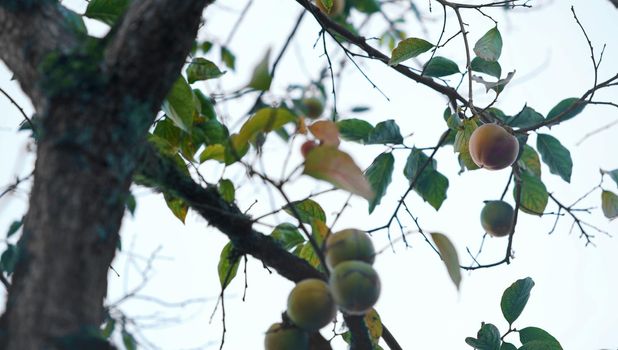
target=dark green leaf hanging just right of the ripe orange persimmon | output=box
[536,134,573,182]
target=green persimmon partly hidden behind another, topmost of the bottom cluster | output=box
[325,229,376,270]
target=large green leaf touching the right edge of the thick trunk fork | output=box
[162,76,195,133]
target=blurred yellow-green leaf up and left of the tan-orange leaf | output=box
[233,108,296,149]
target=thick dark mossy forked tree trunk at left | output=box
[0,0,212,350]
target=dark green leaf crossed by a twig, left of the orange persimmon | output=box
[403,148,449,210]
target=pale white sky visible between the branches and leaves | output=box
[0,0,618,350]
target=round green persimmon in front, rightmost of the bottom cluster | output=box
[328,260,380,315]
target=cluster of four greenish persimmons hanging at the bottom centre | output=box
[264,229,380,350]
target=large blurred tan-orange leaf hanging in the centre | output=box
[303,145,374,200]
